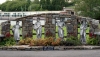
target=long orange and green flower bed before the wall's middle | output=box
[19,37,81,46]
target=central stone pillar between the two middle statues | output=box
[44,15,56,37]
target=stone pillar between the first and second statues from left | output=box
[22,19,33,38]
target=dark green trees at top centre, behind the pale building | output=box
[40,0,74,10]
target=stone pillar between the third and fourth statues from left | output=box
[65,16,78,37]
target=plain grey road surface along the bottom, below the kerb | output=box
[0,50,100,57]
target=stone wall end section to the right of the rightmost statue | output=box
[89,19,100,37]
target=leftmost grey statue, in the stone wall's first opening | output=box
[12,21,20,42]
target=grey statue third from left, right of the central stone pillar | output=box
[57,19,65,39]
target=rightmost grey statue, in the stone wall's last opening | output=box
[80,20,87,44]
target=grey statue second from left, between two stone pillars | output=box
[34,18,42,38]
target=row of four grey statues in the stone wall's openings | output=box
[12,18,87,43]
